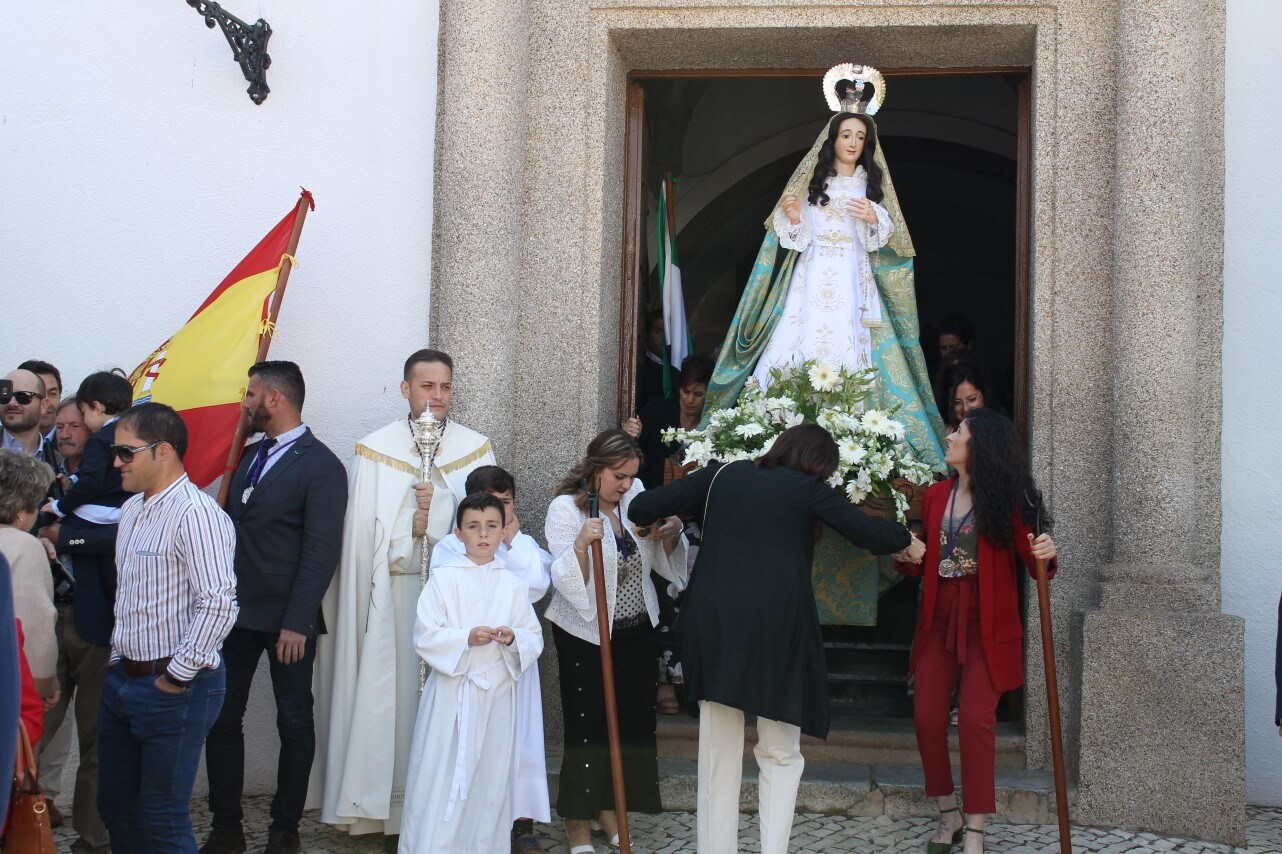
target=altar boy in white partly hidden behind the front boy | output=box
[432,465,553,854]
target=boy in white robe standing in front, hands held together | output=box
[400,494,544,854]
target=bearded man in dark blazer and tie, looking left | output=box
[200,362,347,854]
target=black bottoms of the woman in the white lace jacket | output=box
[553,624,663,821]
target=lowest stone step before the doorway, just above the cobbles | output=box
[547,754,1077,825]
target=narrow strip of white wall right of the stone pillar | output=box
[1220,0,1282,805]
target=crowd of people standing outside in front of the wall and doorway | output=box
[0,338,1054,854]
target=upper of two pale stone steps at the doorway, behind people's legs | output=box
[658,714,1026,769]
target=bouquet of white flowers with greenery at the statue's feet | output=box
[663,359,931,522]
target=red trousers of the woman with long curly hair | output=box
[913,576,1001,816]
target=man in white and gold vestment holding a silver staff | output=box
[308,350,495,836]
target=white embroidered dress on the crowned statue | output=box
[753,165,894,387]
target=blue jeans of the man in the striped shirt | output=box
[97,663,227,854]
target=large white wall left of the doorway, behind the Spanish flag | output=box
[0,0,438,787]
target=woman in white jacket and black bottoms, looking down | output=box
[545,430,687,854]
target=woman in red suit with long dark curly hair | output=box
[896,409,1055,854]
